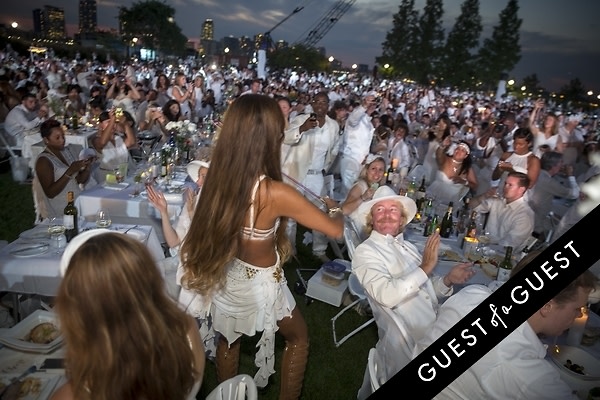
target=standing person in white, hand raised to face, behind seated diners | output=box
[340,92,377,198]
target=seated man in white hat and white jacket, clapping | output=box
[352,186,475,399]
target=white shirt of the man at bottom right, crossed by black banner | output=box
[415,285,577,400]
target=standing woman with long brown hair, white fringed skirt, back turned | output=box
[178,94,343,399]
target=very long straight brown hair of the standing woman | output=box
[181,94,291,295]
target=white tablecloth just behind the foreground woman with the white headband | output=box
[0,222,165,296]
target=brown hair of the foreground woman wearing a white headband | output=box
[56,233,201,400]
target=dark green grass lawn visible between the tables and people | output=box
[0,164,377,400]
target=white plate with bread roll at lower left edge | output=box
[0,310,63,353]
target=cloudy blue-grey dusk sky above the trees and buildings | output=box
[0,0,600,93]
